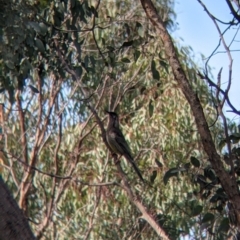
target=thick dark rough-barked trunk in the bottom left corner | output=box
[0,177,35,240]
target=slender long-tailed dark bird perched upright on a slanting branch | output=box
[105,111,144,182]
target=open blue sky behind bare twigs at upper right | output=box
[173,0,240,123]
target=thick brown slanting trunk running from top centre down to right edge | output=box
[141,0,240,227]
